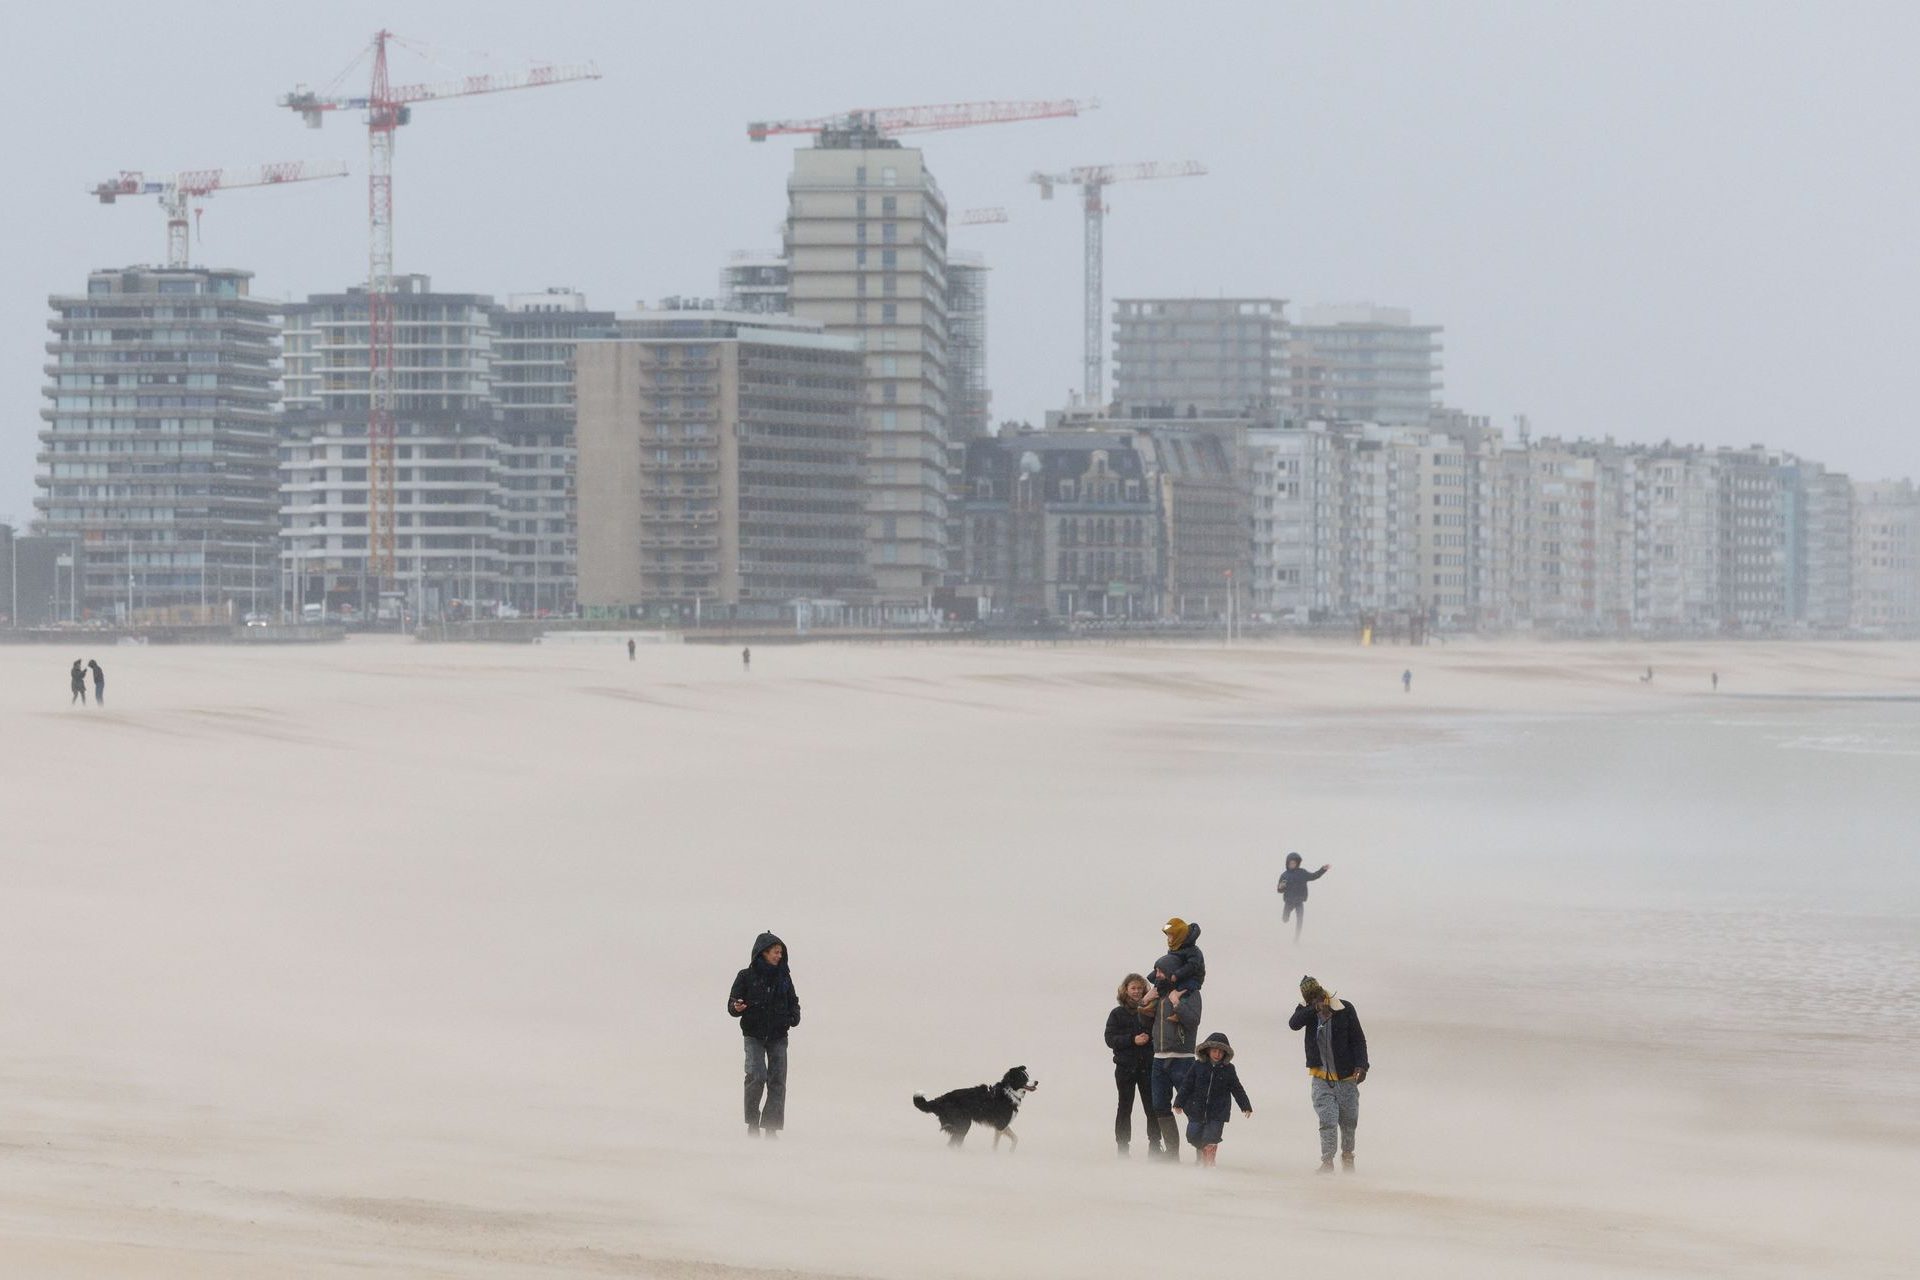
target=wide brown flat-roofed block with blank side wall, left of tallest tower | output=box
[574,309,874,620]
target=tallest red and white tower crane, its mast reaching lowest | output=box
[280,31,599,585]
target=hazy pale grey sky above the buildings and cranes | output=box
[0,0,1920,518]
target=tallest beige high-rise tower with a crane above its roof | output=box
[785,129,948,604]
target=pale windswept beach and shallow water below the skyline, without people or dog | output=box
[0,639,1920,1280]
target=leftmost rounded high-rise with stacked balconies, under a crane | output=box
[35,267,280,622]
